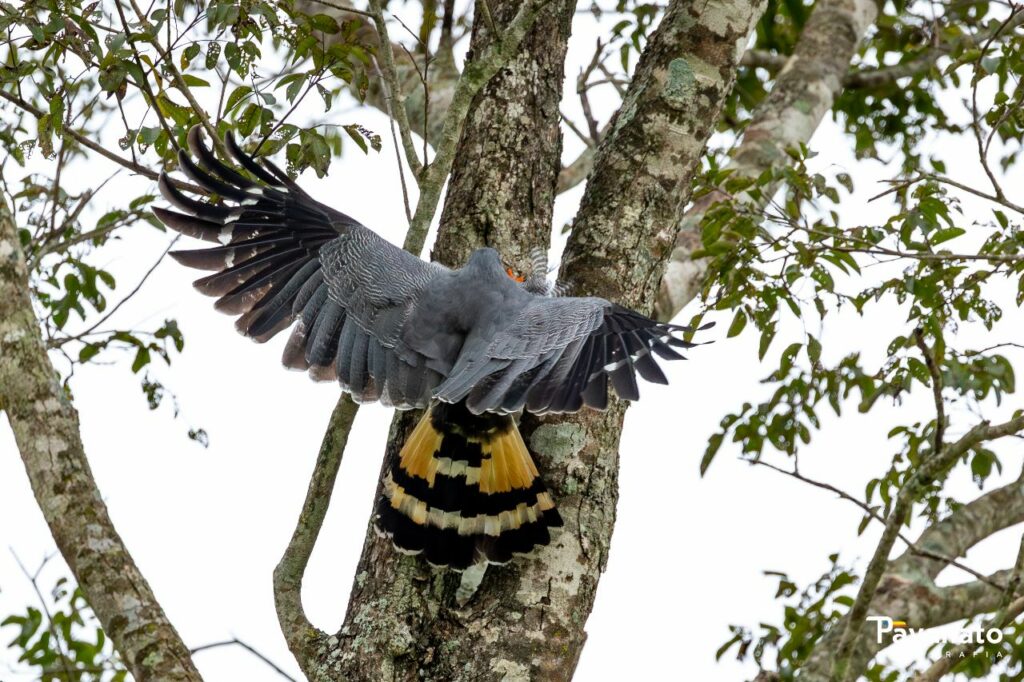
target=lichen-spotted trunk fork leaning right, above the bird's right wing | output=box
[562,0,763,311]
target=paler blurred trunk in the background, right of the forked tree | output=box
[656,0,878,319]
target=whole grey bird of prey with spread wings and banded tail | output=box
[154,128,712,570]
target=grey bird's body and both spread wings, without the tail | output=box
[154,128,712,414]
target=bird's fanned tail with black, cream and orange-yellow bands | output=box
[377,402,562,570]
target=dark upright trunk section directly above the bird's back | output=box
[433,0,575,269]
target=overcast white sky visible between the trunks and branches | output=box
[0,6,1024,682]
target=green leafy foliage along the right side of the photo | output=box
[694,3,1024,680]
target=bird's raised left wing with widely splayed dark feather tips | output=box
[154,128,447,408]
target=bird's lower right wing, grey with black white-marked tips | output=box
[437,296,711,414]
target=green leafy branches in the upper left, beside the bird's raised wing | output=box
[0,0,391,436]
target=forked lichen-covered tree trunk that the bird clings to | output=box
[307,1,760,680]
